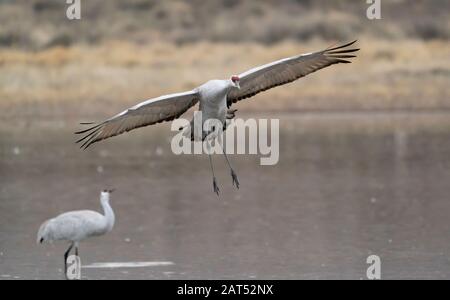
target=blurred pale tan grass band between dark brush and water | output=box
[0,40,450,122]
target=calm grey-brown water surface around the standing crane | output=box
[0,114,450,279]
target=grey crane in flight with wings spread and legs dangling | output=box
[76,41,359,194]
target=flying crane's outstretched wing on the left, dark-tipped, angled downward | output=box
[75,90,199,149]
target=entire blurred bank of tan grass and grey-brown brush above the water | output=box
[0,0,450,120]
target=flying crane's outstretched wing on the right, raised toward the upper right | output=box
[227,41,359,107]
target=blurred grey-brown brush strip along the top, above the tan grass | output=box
[0,0,450,50]
